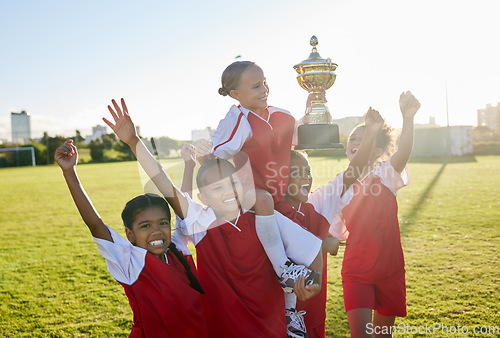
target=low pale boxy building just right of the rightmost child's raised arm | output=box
[412,126,474,157]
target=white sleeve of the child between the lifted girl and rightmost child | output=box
[307,172,354,224]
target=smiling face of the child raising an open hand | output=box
[198,166,243,221]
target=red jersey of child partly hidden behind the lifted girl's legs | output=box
[275,202,330,338]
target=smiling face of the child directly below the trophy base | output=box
[286,157,312,203]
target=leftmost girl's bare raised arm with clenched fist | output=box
[54,140,113,242]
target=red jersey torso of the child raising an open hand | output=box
[196,212,286,338]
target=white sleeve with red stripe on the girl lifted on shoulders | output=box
[211,105,252,160]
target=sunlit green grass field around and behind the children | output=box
[0,156,500,337]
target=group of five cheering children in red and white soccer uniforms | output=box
[55,61,420,337]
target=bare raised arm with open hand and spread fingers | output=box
[103,99,188,219]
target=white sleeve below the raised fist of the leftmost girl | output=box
[94,226,147,285]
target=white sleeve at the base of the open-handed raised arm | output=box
[177,193,217,246]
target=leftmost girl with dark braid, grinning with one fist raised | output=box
[55,140,207,338]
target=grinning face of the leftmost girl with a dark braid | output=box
[125,207,171,260]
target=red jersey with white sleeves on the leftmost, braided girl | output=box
[94,227,207,338]
